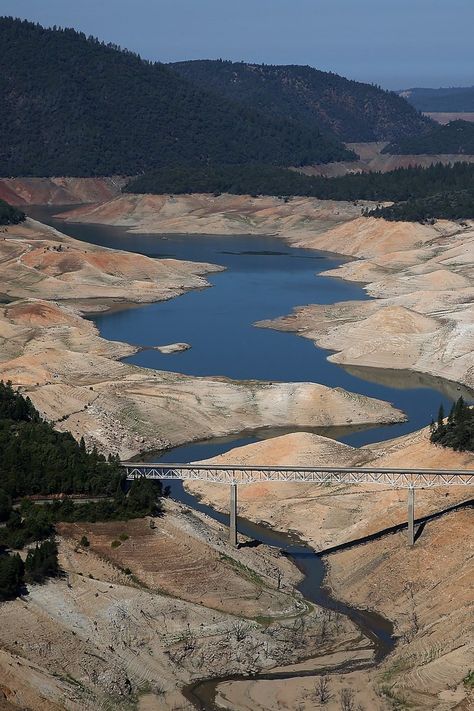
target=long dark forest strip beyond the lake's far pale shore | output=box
[125,163,474,221]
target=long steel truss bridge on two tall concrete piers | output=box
[122,462,474,545]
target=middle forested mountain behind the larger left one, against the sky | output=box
[169,60,432,142]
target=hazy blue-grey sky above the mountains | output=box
[0,0,474,88]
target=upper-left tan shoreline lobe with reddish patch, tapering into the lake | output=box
[0,219,220,310]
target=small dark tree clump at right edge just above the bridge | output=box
[430,397,474,452]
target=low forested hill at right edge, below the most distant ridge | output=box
[382,120,474,155]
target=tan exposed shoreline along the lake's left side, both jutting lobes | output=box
[0,214,405,458]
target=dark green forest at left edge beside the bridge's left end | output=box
[0,382,162,599]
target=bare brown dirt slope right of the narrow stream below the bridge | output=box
[328,509,474,711]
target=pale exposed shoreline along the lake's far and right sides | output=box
[56,195,474,389]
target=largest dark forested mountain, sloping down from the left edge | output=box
[0,18,354,176]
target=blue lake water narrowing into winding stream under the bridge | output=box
[30,208,472,711]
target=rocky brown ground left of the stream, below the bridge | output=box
[0,502,358,711]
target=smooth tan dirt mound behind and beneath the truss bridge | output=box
[186,428,474,550]
